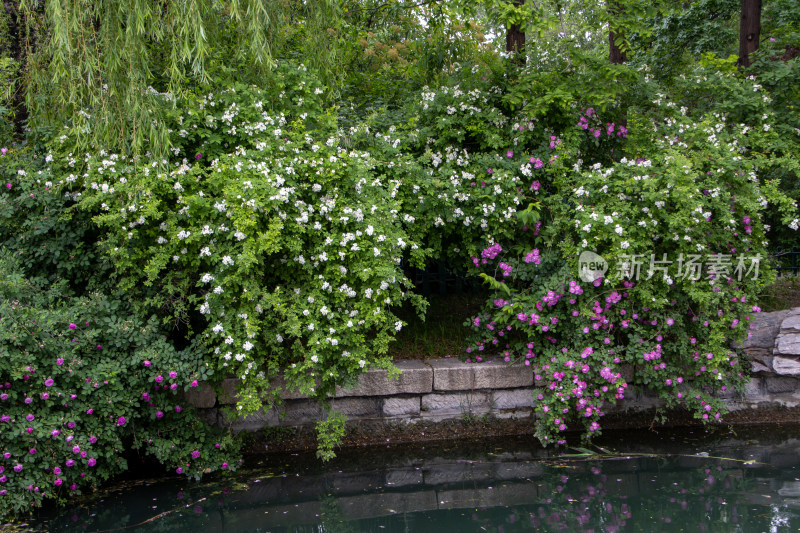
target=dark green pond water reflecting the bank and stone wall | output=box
[32,425,800,533]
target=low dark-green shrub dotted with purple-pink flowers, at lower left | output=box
[0,256,238,515]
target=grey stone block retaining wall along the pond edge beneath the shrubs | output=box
[186,308,800,431]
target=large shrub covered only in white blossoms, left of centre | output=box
[61,67,421,413]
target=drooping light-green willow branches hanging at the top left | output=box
[16,0,336,156]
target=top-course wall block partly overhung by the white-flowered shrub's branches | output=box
[336,361,433,398]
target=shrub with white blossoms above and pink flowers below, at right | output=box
[467,77,797,444]
